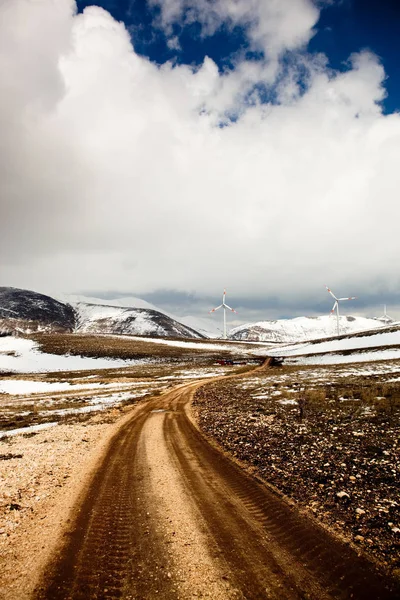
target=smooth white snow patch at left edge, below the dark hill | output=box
[0,336,141,373]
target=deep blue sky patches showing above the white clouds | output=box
[77,0,400,113]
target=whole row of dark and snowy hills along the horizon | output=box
[0,287,385,343]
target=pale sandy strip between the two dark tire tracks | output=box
[141,411,241,600]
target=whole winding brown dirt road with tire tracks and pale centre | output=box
[37,383,395,600]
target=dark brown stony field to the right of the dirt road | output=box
[194,365,400,573]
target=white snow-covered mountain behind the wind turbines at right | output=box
[229,315,383,343]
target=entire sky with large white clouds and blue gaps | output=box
[0,0,400,324]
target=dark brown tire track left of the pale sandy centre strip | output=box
[37,404,177,600]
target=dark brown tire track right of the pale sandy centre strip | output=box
[167,394,396,600]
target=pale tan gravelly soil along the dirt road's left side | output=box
[0,408,144,600]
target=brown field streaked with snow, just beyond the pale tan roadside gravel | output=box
[0,362,232,438]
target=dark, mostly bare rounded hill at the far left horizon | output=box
[0,287,75,332]
